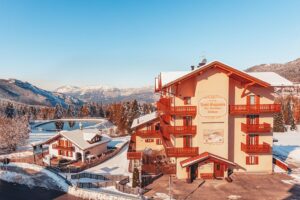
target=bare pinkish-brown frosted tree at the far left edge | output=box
[0,116,30,152]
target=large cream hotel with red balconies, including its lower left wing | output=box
[127,61,289,182]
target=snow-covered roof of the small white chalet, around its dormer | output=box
[59,129,111,150]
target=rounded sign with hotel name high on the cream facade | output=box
[199,95,227,118]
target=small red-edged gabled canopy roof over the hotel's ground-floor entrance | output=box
[180,152,236,167]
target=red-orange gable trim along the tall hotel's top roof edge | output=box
[162,61,271,88]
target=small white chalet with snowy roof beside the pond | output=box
[43,129,111,162]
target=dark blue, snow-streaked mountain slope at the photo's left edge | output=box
[0,79,82,107]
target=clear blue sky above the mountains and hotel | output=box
[0,0,300,90]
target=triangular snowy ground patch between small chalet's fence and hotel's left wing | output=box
[85,145,131,177]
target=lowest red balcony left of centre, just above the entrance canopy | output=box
[166,147,198,157]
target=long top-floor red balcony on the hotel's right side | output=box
[229,104,281,115]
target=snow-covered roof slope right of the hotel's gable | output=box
[247,72,293,87]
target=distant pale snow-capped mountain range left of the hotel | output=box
[55,85,157,103]
